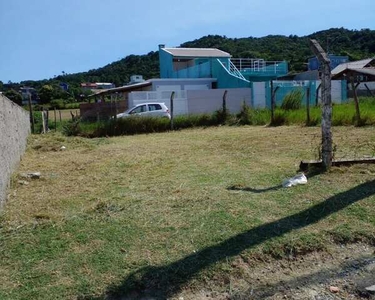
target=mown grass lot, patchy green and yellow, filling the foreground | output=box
[0,126,375,299]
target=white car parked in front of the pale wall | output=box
[117,102,171,119]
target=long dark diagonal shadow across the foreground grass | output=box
[83,180,375,299]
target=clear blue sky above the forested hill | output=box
[0,0,375,83]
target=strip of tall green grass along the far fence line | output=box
[63,97,375,137]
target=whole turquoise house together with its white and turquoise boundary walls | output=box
[81,45,352,117]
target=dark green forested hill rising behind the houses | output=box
[4,28,375,88]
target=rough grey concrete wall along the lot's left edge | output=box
[0,94,30,207]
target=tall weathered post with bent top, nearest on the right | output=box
[310,39,332,170]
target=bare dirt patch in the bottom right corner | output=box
[176,244,375,300]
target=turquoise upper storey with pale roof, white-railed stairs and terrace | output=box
[159,45,288,89]
